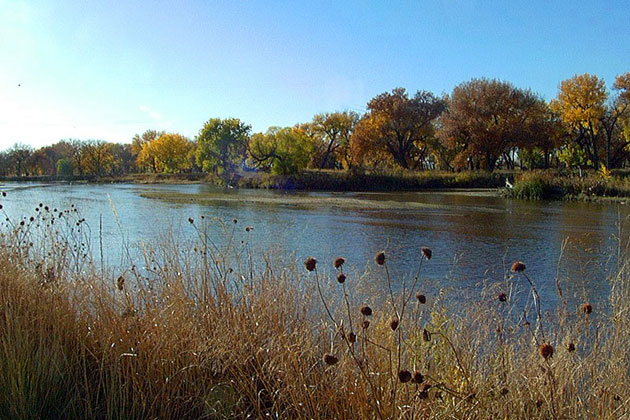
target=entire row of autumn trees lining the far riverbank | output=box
[0,72,630,177]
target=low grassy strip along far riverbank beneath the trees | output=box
[0,170,630,201]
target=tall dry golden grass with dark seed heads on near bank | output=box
[0,196,630,419]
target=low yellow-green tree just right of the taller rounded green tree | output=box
[248,127,313,175]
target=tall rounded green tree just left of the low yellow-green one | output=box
[196,118,251,173]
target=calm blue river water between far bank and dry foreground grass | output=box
[2,184,630,301]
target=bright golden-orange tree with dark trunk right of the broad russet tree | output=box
[551,73,608,167]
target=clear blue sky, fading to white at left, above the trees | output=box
[0,0,630,149]
